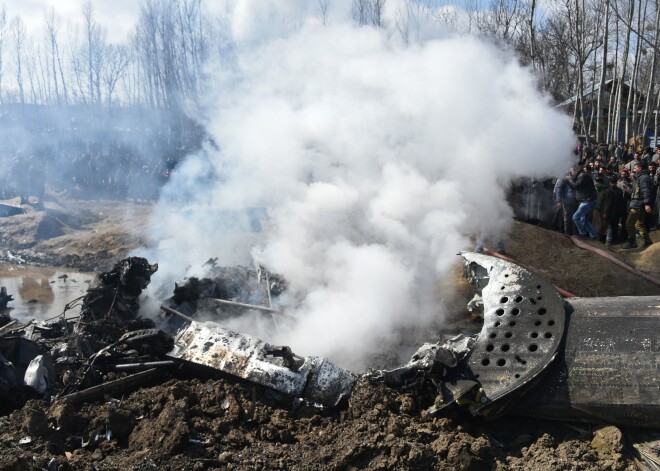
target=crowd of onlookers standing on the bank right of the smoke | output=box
[552,144,660,249]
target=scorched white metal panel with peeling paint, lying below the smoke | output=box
[171,322,356,407]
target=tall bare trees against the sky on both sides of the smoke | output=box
[0,0,660,146]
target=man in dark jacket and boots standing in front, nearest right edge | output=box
[623,161,654,249]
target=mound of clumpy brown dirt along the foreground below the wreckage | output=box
[0,379,634,470]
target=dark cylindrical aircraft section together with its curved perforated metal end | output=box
[462,253,660,427]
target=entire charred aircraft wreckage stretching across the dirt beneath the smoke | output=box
[0,252,660,428]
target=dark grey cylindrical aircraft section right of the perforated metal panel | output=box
[515,296,660,427]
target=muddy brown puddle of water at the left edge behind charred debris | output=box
[0,263,94,321]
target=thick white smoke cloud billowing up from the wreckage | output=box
[142,1,572,369]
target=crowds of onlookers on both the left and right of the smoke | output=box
[0,129,660,252]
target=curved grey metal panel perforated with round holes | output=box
[461,252,566,402]
